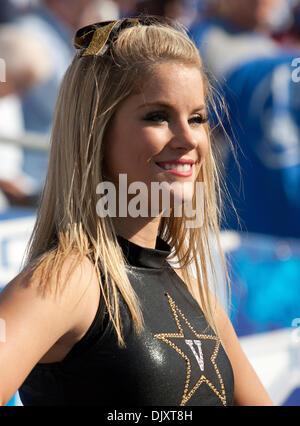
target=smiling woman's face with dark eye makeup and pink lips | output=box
[104,61,208,213]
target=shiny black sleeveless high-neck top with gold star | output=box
[19,236,234,407]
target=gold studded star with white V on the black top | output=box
[153,293,226,405]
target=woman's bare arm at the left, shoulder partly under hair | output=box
[0,255,99,405]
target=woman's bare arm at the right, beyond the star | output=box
[172,270,273,405]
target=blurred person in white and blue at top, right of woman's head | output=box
[191,0,281,78]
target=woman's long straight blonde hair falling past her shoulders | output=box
[26,18,231,346]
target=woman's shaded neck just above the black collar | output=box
[112,216,160,249]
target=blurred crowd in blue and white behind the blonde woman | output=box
[0,0,300,238]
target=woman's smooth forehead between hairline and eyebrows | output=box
[128,61,205,110]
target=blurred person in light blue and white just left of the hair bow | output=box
[10,0,117,192]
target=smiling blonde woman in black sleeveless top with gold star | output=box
[0,17,271,406]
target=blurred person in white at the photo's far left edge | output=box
[0,24,51,210]
